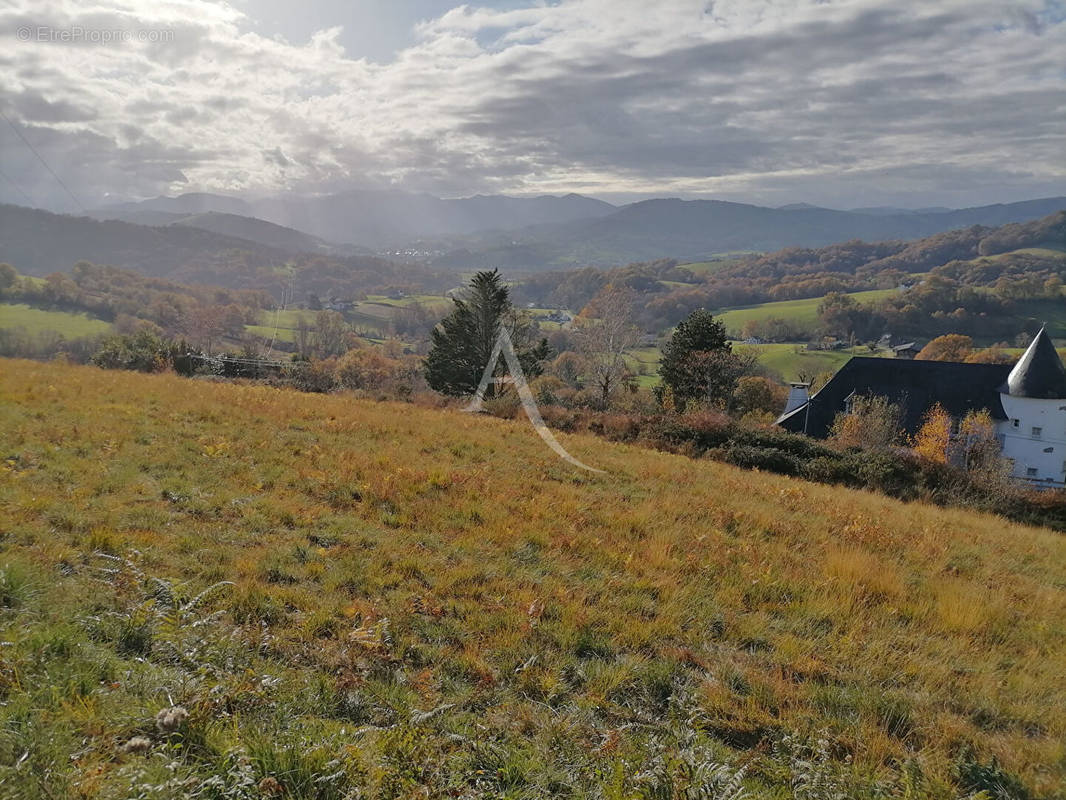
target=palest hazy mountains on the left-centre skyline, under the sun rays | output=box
[94,190,616,249]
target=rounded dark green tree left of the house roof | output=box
[658,309,752,411]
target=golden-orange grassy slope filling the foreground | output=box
[0,361,1066,798]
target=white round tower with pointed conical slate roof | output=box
[997,329,1066,486]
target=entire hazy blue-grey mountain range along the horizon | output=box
[93,191,1066,270]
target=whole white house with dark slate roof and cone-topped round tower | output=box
[777,329,1066,486]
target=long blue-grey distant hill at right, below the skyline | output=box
[424,197,1066,269]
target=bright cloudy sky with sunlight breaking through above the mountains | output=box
[0,0,1066,210]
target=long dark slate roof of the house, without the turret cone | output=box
[777,356,1011,438]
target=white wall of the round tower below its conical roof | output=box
[998,395,1066,484]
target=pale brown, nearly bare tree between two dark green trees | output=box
[576,285,641,411]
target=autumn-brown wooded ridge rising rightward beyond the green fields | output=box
[518,211,1066,336]
